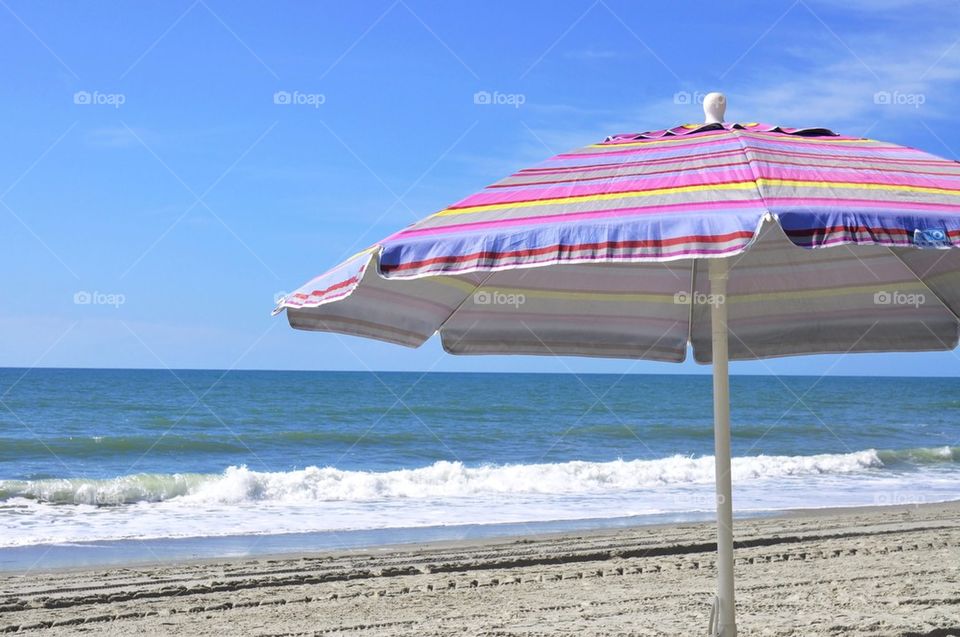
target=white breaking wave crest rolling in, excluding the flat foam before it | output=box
[0,447,936,505]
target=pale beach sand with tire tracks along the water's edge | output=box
[0,503,960,637]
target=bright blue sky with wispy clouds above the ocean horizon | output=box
[0,0,960,376]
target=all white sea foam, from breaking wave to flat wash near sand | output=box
[0,449,960,547]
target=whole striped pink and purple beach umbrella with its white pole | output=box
[276,93,960,637]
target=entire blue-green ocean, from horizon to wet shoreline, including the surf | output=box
[0,369,960,568]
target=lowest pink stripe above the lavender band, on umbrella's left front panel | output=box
[384,199,765,238]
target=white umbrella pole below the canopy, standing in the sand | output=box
[709,259,737,637]
